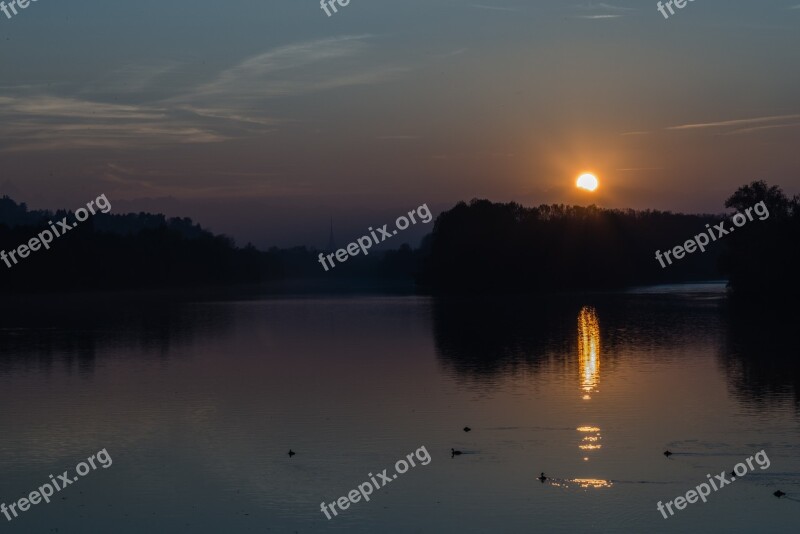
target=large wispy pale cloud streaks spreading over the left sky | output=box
[0,35,408,151]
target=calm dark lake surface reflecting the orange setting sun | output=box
[0,285,800,534]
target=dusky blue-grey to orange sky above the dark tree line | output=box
[0,0,800,248]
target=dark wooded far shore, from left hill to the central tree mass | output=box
[0,196,421,293]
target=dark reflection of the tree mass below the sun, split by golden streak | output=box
[433,294,720,383]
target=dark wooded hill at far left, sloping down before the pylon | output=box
[0,197,283,293]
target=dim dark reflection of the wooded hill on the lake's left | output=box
[0,294,232,373]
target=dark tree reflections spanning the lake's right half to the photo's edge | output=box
[433,295,800,408]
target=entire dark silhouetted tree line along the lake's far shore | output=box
[0,181,800,302]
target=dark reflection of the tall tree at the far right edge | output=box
[719,310,800,409]
